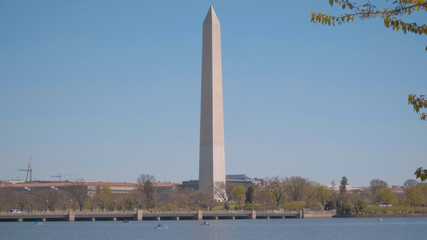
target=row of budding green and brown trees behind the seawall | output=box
[0,174,427,215]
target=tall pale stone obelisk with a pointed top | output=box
[199,6,225,200]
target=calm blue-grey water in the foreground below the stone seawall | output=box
[0,218,427,240]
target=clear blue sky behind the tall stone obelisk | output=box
[0,0,427,186]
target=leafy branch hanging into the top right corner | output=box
[311,0,427,50]
